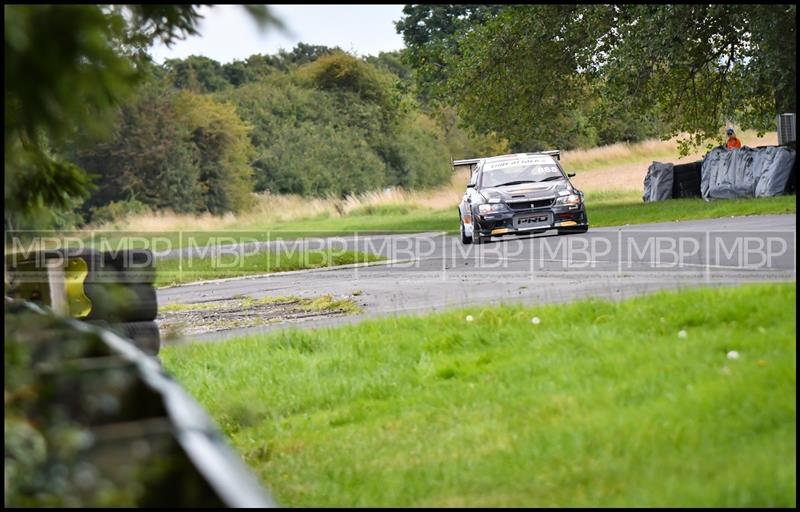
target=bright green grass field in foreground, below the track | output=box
[162,283,797,507]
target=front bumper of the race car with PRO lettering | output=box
[472,204,589,236]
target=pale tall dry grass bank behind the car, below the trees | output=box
[93,131,777,231]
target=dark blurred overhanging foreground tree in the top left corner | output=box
[4,4,277,224]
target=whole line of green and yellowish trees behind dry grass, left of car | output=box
[9,37,503,227]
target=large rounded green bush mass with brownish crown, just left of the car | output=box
[220,53,450,196]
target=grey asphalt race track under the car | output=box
[158,215,796,341]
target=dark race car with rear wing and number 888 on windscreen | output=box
[453,151,589,244]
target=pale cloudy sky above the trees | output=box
[150,4,403,64]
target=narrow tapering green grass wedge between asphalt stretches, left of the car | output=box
[155,249,383,286]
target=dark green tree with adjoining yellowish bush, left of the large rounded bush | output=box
[78,83,253,215]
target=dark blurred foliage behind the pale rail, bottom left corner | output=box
[3,303,223,507]
